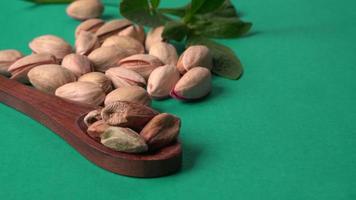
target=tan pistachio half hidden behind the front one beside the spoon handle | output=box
[78,72,112,94]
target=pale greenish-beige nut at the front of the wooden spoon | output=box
[100,127,148,153]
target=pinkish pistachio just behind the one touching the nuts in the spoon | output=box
[105,67,146,88]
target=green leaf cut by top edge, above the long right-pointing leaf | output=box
[190,0,225,15]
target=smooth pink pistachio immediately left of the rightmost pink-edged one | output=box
[147,65,180,99]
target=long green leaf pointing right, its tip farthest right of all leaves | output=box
[194,17,252,38]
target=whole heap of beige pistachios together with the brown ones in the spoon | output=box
[0,0,217,153]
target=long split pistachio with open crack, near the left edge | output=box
[8,54,57,83]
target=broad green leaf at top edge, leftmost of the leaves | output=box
[120,0,169,27]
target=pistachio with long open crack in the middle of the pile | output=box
[119,54,163,80]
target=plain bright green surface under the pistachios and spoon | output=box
[0,0,356,200]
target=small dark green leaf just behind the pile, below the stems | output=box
[162,21,188,41]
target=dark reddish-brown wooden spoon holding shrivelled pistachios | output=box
[0,75,182,177]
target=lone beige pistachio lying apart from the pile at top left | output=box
[66,0,104,20]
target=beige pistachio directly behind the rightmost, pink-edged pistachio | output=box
[177,45,213,74]
